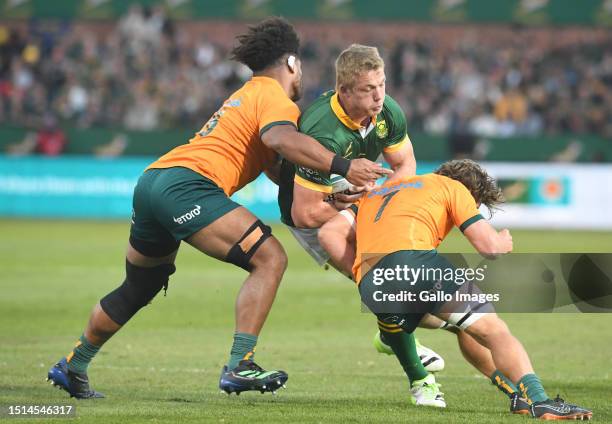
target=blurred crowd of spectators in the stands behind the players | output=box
[0,6,612,137]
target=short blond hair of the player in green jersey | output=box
[336,44,385,89]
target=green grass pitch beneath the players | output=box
[0,220,612,424]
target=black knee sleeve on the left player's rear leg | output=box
[100,261,176,325]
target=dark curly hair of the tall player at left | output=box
[230,16,300,72]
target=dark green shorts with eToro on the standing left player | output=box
[130,167,240,257]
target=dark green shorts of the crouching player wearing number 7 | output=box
[359,250,461,333]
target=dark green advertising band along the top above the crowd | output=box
[0,0,612,26]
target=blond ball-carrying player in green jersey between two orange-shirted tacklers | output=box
[278,44,516,407]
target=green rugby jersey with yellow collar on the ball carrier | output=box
[278,90,410,227]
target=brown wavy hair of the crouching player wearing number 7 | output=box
[434,159,504,215]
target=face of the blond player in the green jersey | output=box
[343,68,385,117]
